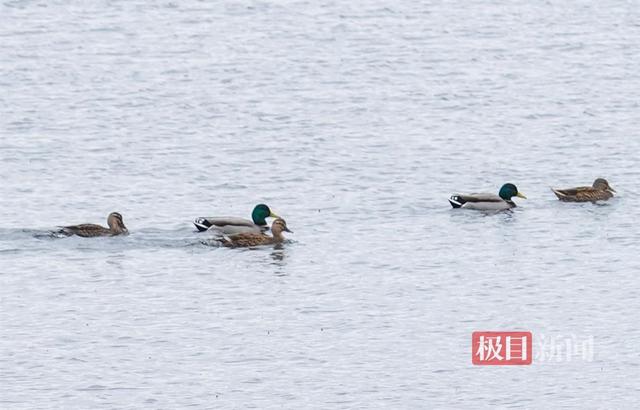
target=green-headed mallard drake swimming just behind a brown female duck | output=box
[193,204,278,235]
